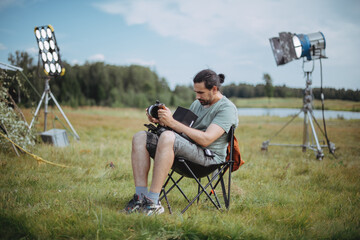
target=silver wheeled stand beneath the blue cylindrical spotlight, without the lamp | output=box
[261,62,335,160]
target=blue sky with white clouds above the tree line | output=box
[0,0,360,90]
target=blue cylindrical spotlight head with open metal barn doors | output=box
[269,32,326,66]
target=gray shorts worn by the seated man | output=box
[146,132,218,166]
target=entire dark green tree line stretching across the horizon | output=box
[3,51,360,108]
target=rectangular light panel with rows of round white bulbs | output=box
[34,25,65,76]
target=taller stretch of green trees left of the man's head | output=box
[4,51,195,108]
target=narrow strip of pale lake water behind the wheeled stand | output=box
[238,108,360,119]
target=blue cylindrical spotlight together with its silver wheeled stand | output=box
[261,32,335,160]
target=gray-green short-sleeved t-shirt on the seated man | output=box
[190,96,239,163]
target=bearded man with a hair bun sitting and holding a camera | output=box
[125,69,238,215]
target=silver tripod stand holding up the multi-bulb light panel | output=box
[29,78,80,140]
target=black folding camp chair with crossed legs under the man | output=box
[160,126,235,213]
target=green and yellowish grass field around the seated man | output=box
[0,107,360,239]
